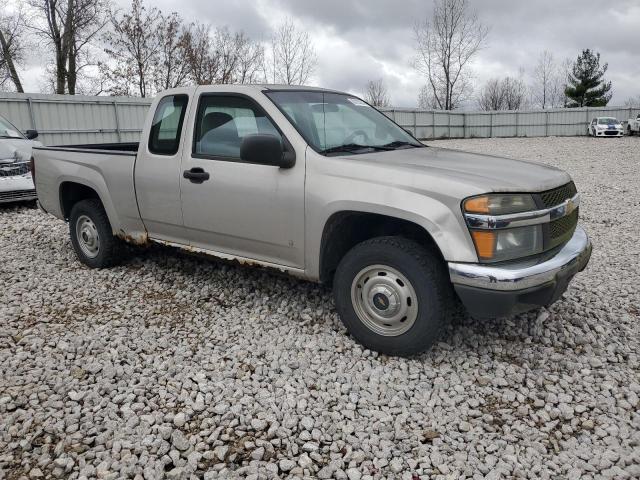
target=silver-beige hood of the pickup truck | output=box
[345,147,571,192]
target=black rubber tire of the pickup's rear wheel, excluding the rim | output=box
[69,199,122,268]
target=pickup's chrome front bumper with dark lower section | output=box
[449,226,592,317]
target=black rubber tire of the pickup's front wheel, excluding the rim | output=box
[333,237,453,356]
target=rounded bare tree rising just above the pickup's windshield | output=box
[267,20,318,85]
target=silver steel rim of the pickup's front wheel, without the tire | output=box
[351,265,418,337]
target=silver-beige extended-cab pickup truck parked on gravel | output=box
[32,85,591,355]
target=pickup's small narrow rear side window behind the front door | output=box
[149,95,189,155]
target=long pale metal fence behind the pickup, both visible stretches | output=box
[0,93,640,145]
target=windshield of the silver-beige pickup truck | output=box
[265,90,424,155]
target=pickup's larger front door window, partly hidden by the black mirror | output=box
[193,95,282,159]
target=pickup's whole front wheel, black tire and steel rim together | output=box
[334,237,451,356]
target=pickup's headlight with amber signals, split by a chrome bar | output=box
[463,194,544,262]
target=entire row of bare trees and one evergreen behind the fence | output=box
[0,0,638,110]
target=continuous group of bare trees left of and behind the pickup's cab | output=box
[0,0,317,97]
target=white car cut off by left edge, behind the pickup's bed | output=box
[0,116,42,203]
